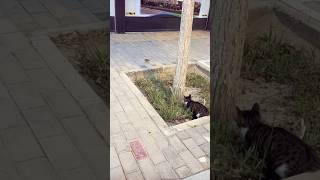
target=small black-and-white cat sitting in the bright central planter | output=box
[184,94,209,119]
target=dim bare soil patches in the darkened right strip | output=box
[237,9,320,135]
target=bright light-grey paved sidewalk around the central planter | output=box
[110,31,210,180]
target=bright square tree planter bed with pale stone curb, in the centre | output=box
[124,64,210,134]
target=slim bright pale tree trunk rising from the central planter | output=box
[173,0,194,97]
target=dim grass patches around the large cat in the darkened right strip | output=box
[212,31,320,180]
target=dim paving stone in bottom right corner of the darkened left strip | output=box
[80,144,110,180]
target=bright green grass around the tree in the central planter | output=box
[135,74,209,122]
